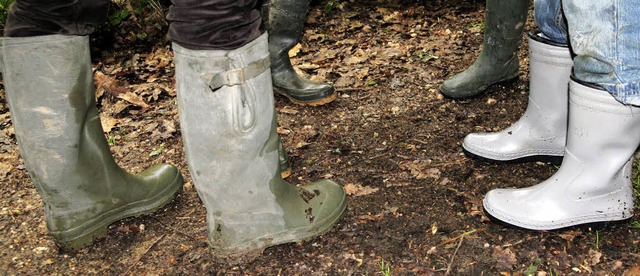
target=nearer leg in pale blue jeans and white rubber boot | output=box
[483,0,640,230]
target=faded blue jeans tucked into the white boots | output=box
[535,0,640,106]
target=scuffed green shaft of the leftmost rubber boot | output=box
[3,35,119,206]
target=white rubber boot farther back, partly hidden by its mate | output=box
[462,33,573,164]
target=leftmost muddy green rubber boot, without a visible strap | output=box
[2,35,182,250]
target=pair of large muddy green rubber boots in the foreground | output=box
[2,16,346,261]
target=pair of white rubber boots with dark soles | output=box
[463,31,640,230]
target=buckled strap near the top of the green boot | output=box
[202,56,271,91]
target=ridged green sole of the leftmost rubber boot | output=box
[50,174,183,251]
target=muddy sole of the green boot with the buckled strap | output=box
[211,191,347,265]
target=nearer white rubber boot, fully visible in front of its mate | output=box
[484,81,640,230]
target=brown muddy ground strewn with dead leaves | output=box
[0,0,640,275]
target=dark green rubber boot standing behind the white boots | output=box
[440,0,529,99]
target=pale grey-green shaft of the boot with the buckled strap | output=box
[173,35,279,216]
